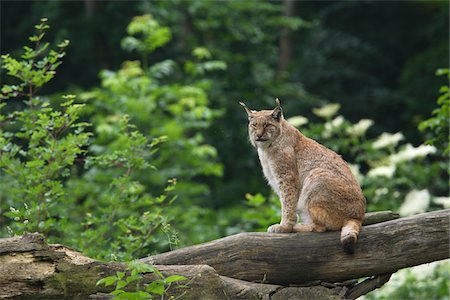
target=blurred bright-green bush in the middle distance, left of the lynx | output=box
[78,15,226,247]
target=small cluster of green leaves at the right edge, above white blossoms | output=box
[419,69,450,155]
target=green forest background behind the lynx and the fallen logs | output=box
[0,0,450,299]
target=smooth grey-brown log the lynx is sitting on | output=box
[140,209,450,285]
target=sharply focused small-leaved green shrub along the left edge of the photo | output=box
[0,19,91,233]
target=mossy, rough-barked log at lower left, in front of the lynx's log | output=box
[0,233,342,300]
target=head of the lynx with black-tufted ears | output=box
[239,99,283,147]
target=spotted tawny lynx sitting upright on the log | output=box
[240,99,366,253]
